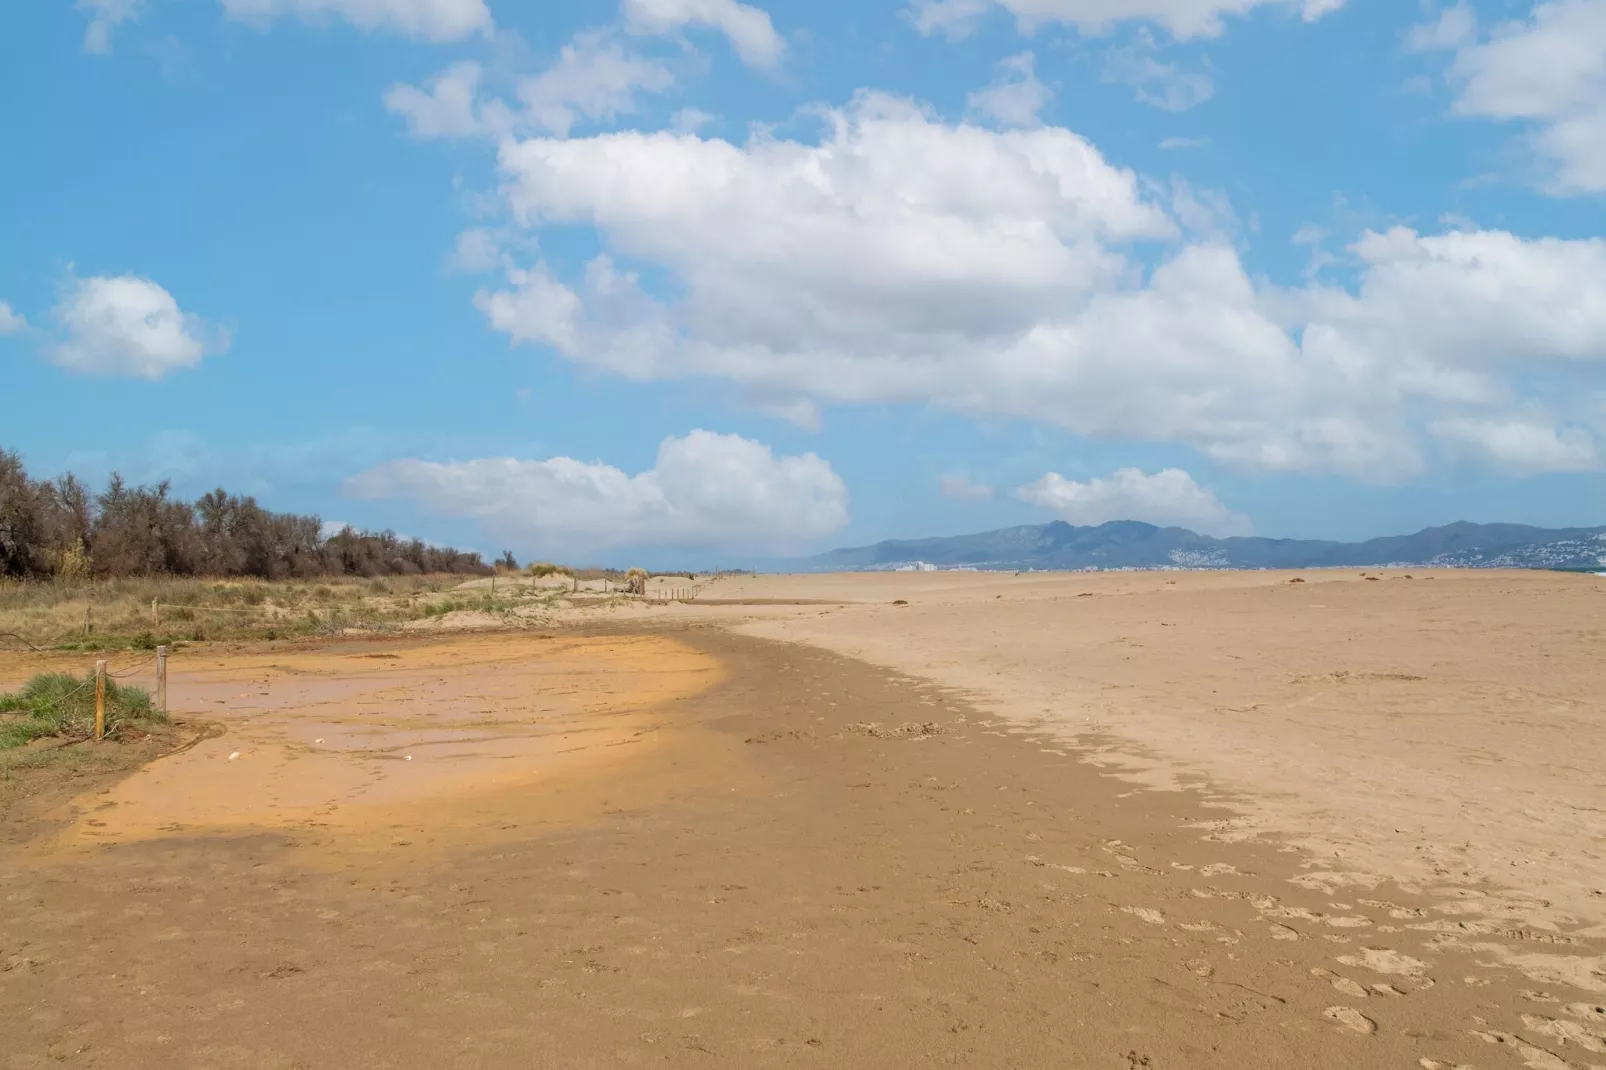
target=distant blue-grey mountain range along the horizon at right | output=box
[787,521,1606,572]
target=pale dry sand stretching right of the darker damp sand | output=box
[616,570,1606,931]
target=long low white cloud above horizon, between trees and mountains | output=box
[345,431,848,553]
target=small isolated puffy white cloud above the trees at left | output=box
[51,275,228,379]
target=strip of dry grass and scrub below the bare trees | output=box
[0,575,619,651]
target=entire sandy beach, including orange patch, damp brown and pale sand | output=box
[0,572,1606,1070]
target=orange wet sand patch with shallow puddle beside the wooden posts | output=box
[39,635,721,847]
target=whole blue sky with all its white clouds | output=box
[0,0,1606,562]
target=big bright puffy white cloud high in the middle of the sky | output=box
[501,95,1174,350]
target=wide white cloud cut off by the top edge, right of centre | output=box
[909,0,1344,39]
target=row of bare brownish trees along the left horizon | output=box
[0,450,488,582]
